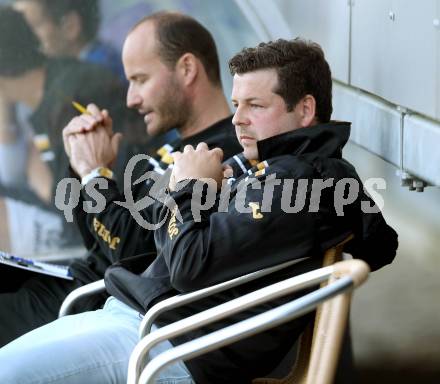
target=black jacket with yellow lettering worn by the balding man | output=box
[70,117,241,283]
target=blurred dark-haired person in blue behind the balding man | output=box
[13,0,124,79]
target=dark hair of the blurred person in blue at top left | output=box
[16,0,101,43]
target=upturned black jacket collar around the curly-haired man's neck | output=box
[257,121,351,161]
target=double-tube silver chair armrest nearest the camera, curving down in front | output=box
[136,260,369,384]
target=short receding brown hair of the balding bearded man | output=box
[132,12,221,85]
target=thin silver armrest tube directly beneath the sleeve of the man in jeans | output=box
[139,257,309,339]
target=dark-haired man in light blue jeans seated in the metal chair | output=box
[0,36,397,384]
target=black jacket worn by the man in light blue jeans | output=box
[106,123,397,383]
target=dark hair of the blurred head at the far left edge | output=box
[0,6,46,77]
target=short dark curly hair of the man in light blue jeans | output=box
[229,38,333,123]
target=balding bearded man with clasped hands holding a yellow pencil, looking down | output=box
[0,13,241,352]
